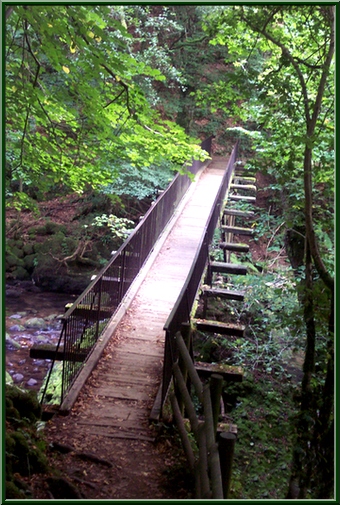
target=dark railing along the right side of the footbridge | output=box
[161,142,238,407]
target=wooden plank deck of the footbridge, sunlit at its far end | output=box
[62,158,228,443]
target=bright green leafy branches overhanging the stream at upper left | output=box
[6,5,204,199]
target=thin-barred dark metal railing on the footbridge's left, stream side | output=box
[41,137,213,403]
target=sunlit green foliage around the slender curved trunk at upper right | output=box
[201,5,335,276]
